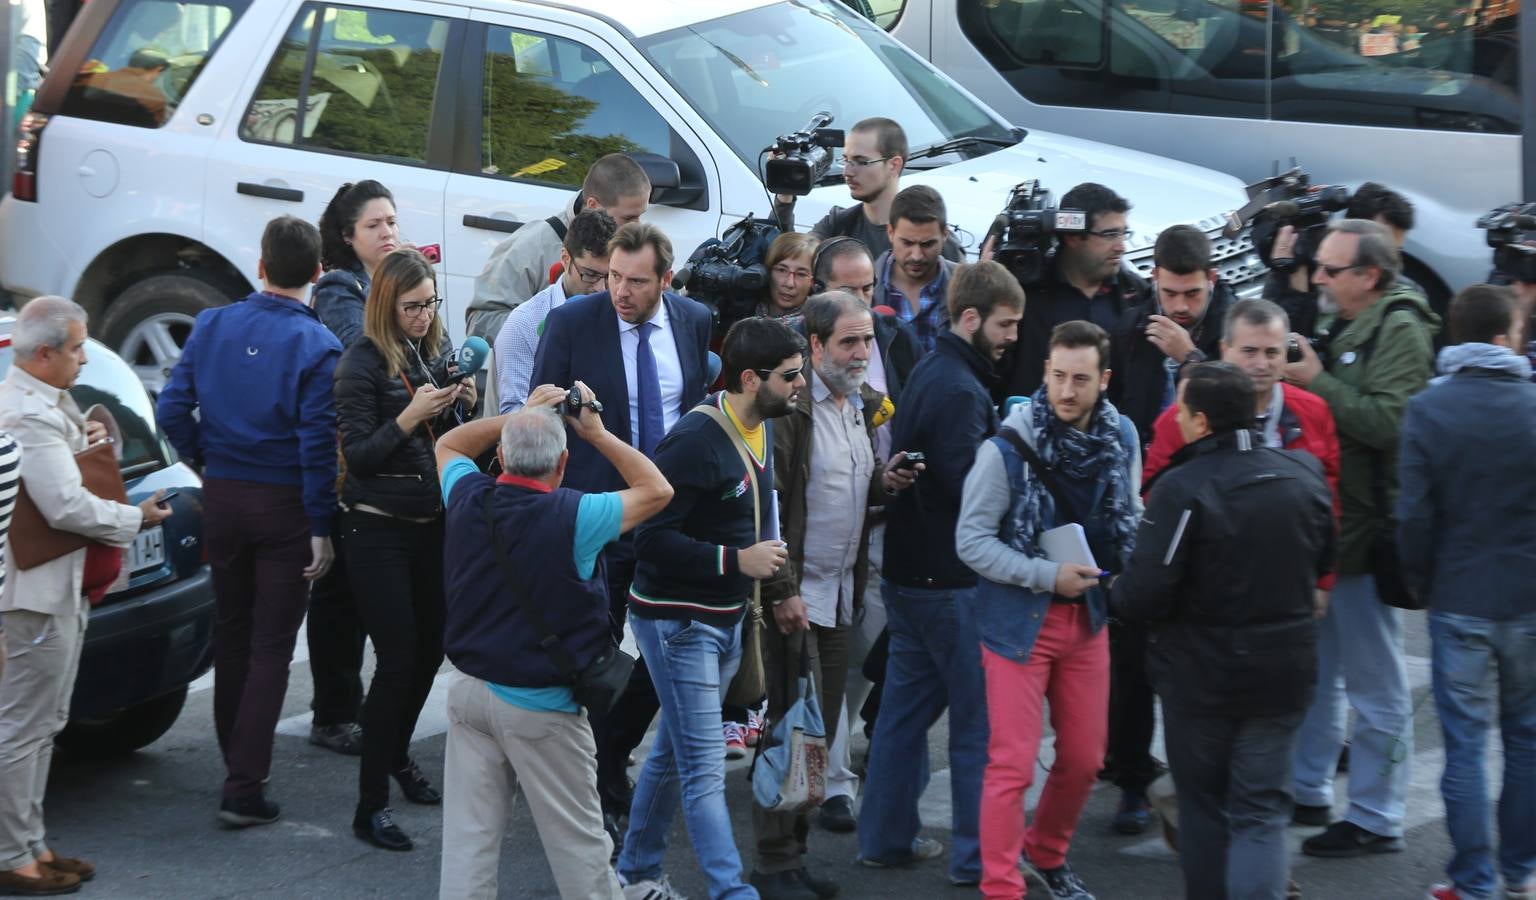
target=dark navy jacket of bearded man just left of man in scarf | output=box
[882,332,997,588]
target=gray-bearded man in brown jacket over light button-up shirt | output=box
[751,290,911,900]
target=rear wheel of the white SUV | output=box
[101,272,246,395]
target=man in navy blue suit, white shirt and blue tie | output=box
[528,223,711,852]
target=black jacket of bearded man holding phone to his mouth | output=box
[1109,281,1236,448]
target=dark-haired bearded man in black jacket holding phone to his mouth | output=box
[1109,224,1235,447]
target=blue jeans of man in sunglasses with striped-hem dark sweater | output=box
[617,616,757,900]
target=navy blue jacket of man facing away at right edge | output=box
[1398,369,1536,619]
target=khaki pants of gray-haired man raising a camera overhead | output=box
[439,673,624,900]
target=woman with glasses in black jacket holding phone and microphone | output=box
[336,250,475,851]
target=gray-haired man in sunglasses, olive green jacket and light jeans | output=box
[1286,218,1439,857]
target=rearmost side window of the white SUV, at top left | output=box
[63,0,250,127]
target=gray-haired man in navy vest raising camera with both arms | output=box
[436,382,673,900]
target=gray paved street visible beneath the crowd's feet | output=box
[48,614,1468,900]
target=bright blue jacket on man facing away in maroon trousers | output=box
[155,292,341,538]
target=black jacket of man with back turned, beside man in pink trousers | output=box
[1111,432,1335,717]
